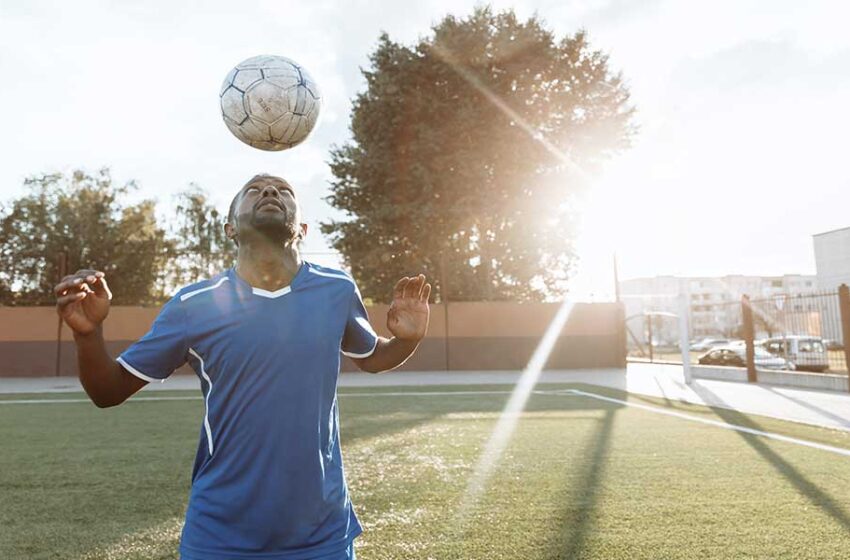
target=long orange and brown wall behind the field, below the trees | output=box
[0,302,626,377]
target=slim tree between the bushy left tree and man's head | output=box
[168,184,236,286]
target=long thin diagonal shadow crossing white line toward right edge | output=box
[693,386,850,530]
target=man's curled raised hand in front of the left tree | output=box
[54,270,112,334]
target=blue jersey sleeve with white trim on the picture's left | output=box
[117,296,189,381]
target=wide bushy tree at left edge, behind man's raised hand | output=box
[0,169,171,305]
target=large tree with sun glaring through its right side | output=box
[322,8,634,301]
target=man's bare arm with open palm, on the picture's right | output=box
[352,274,431,373]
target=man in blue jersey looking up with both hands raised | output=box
[56,175,431,560]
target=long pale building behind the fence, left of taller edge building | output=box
[620,274,817,346]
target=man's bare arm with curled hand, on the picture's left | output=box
[55,270,147,408]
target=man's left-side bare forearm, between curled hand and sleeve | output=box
[74,327,144,408]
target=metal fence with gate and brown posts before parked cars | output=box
[625,285,850,379]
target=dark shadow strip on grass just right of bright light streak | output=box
[544,399,618,560]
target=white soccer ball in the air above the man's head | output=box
[219,55,322,152]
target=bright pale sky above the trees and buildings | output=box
[0,0,850,300]
